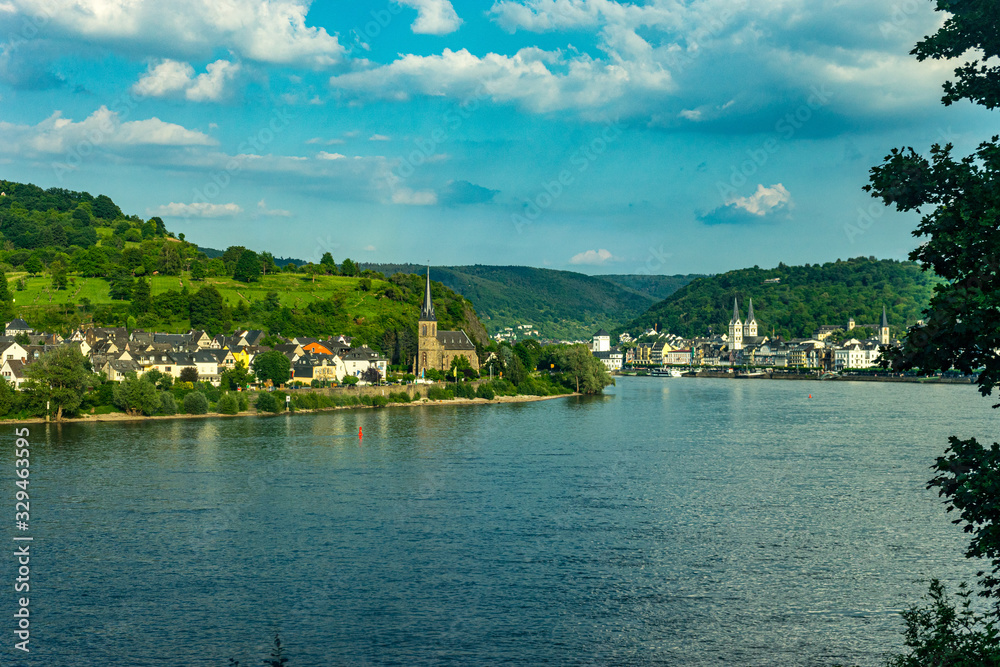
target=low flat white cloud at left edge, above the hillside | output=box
[0,106,217,155]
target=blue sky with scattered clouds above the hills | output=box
[0,0,996,274]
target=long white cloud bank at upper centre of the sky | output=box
[330,48,673,112]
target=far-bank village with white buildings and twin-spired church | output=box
[591,299,899,372]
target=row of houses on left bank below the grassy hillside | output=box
[0,320,388,389]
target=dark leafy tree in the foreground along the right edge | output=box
[865,0,1000,664]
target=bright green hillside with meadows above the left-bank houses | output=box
[0,180,487,360]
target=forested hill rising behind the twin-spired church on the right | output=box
[620,257,940,338]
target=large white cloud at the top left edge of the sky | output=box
[5,0,344,67]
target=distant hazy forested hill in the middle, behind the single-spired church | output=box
[363,264,700,339]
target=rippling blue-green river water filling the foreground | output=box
[0,378,1000,667]
